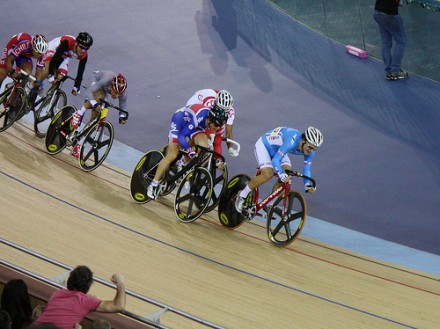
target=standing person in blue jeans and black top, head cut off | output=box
[374,0,408,80]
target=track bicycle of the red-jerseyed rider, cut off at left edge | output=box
[0,69,35,131]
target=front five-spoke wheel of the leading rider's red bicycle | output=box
[266,191,307,246]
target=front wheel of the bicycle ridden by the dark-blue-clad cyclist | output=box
[174,167,213,223]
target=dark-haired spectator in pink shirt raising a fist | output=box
[35,266,126,329]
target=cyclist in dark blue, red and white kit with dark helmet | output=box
[147,104,226,200]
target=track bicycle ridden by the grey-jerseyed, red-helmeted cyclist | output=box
[45,100,128,171]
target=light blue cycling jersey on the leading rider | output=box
[261,127,315,183]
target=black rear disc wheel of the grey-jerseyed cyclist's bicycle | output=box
[44,105,76,155]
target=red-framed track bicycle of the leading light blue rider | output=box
[218,168,316,246]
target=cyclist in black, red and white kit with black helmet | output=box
[33,32,93,100]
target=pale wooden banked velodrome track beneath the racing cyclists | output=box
[0,123,440,328]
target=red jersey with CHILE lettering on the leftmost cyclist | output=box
[0,32,33,68]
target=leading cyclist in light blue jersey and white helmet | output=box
[235,127,324,213]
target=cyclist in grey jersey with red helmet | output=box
[72,71,128,158]
